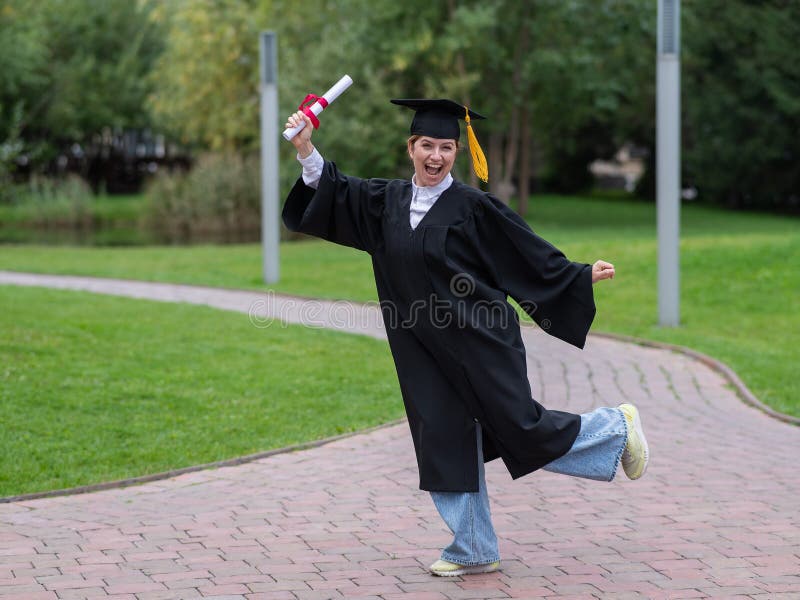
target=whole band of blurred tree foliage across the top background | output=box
[0,0,800,208]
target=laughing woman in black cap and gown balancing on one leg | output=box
[283,100,649,576]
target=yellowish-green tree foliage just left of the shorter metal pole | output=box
[149,0,259,151]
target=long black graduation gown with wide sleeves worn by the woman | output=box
[283,161,595,492]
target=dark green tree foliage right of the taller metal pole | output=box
[683,0,800,210]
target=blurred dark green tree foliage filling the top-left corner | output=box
[0,0,163,159]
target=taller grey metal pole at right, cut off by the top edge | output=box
[656,0,681,327]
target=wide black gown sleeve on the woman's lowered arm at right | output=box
[476,198,595,348]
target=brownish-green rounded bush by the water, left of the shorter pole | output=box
[145,154,261,243]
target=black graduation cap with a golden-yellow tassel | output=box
[391,98,489,181]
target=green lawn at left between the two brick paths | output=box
[0,286,403,496]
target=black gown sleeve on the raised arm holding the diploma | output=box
[282,161,388,254]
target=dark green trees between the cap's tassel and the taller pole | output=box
[428,0,655,206]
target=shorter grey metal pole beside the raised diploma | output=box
[259,31,280,283]
